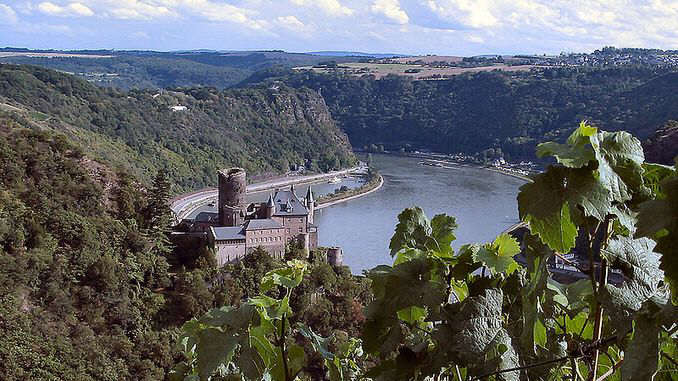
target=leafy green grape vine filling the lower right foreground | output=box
[172,123,678,381]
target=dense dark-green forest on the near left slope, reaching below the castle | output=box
[0,116,369,381]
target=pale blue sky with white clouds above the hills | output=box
[0,0,678,56]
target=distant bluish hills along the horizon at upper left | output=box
[0,48,362,89]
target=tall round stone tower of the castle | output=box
[219,168,247,226]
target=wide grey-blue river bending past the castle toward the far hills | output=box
[315,155,525,274]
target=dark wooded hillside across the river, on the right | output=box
[274,66,678,159]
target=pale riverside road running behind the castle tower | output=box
[170,167,365,222]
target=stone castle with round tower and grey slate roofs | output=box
[194,168,318,266]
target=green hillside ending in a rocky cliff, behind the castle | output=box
[0,65,355,191]
